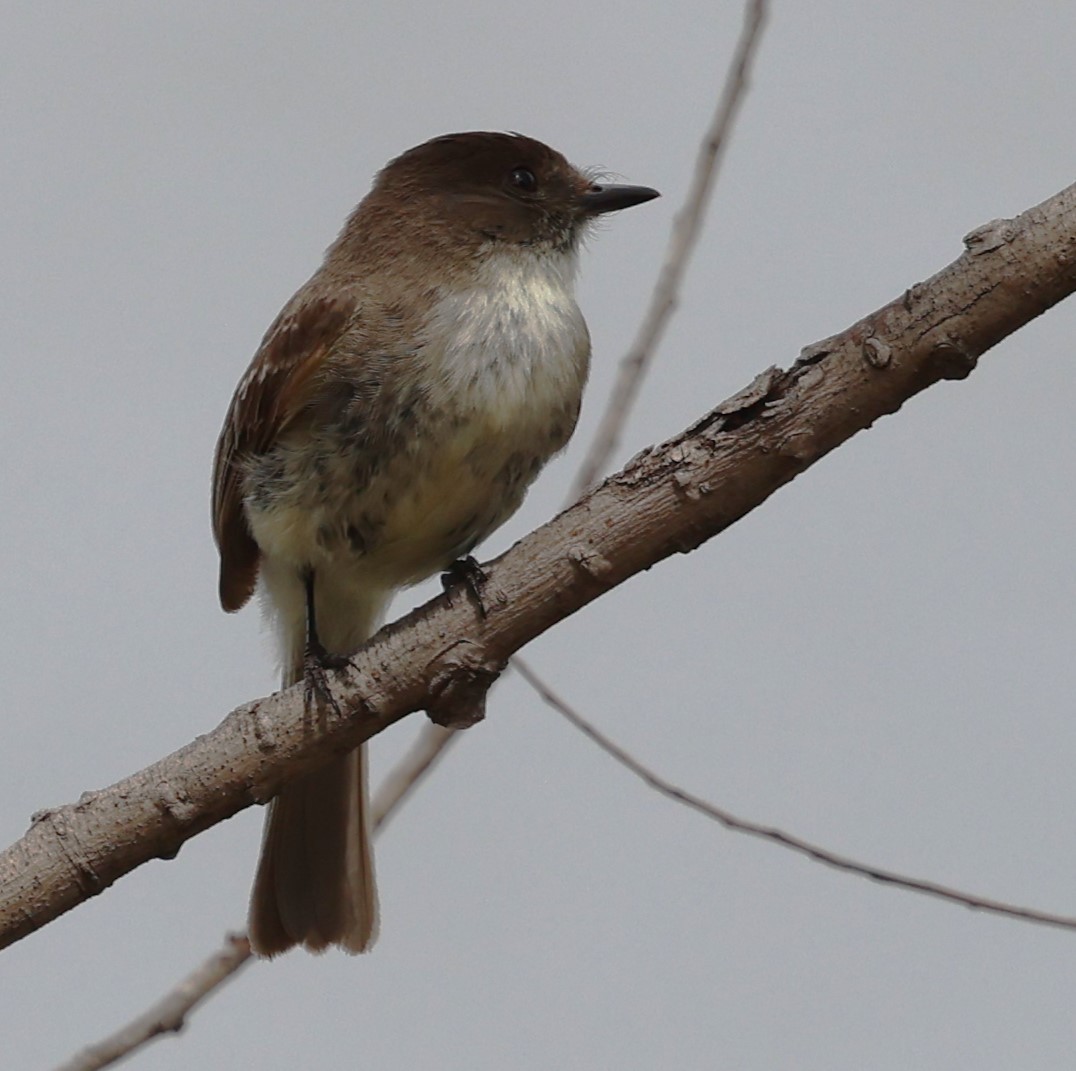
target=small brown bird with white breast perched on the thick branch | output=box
[213,132,657,956]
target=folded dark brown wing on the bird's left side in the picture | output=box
[213,294,355,612]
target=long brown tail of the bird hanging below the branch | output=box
[247,661,378,956]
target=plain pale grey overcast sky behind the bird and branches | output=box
[0,0,1076,1071]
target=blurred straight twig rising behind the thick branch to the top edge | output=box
[568,0,767,504]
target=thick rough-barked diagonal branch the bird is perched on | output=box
[0,179,1076,947]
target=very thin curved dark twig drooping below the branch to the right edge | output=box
[512,656,1076,930]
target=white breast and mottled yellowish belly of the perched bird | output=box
[247,248,590,586]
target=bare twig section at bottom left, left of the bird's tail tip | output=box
[57,933,251,1071]
